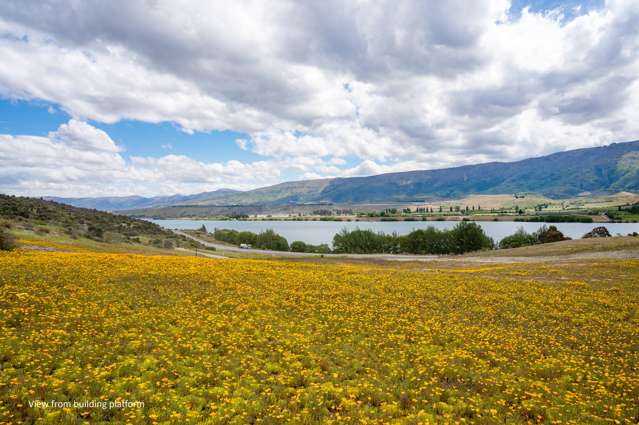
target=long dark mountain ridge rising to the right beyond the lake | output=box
[49,141,639,211]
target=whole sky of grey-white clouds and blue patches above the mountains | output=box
[0,0,639,196]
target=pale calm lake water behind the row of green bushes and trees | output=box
[150,220,639,246]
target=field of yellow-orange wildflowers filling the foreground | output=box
[0,252,639,424]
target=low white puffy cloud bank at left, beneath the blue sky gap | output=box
[0,119,279,196]
